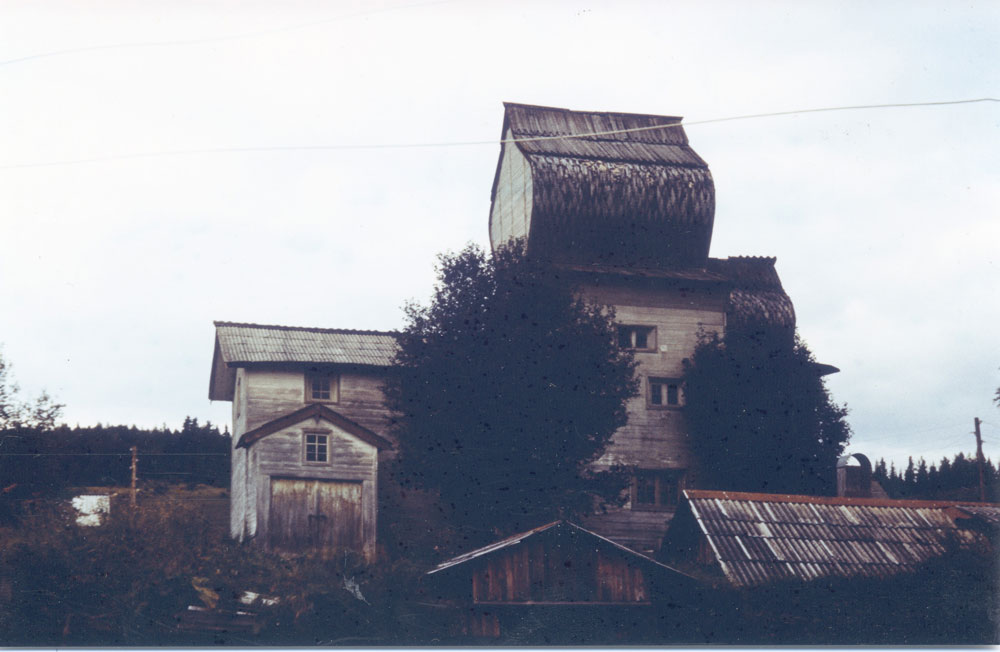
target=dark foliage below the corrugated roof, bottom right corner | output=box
[691,549,1000,646]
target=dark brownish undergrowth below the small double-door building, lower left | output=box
[0,497,426,647]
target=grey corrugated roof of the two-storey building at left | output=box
[215,321,396,367]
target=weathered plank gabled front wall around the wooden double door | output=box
[247,419,378,559]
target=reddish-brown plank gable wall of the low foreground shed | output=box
[472,540,649,604]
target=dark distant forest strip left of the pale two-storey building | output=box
[0,417,230,497]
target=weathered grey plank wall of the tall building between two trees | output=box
[581,281,726,552]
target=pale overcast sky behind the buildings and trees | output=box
[0,0,1000,462]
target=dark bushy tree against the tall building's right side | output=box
[685,332,850,494]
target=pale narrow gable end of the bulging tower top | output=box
[490,129,534,248]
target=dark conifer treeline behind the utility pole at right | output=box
[873,453,1000,502]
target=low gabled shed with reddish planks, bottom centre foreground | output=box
[428,521,693,642]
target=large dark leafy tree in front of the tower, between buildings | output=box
[386,245,637,540]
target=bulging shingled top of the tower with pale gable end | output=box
[490,103,715,267]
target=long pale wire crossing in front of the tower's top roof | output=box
[0,97,1000,170]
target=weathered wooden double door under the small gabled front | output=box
[267,478,362,552]
